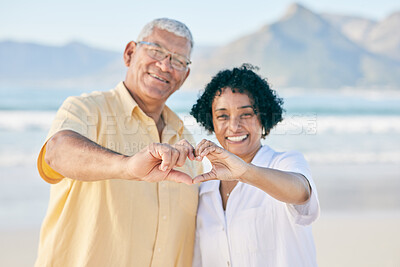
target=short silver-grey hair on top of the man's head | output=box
[137,18,193,50]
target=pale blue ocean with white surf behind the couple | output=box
[0,88,400,228]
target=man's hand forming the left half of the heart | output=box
[126,143,194,184]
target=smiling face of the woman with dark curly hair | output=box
[212,88,262,162]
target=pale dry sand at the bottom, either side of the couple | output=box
[0,212,400,267]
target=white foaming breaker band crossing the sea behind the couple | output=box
[0,110,400,136]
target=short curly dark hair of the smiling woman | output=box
[190,64,284,138]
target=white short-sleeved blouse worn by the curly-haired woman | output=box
[193,146,319,267]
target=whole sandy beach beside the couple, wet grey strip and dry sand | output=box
[0,164,400,267]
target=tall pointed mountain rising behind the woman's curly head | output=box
[189,4,400,88]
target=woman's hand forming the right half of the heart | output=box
[193,139,248,183]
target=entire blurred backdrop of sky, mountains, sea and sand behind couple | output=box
[0,0,400,267]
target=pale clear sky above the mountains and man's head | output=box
[0,0,400,51]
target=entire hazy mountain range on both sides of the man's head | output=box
[0,4,400,90]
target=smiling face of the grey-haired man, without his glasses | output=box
[124,28,191,104]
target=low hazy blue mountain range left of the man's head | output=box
[0,41,123,88]
